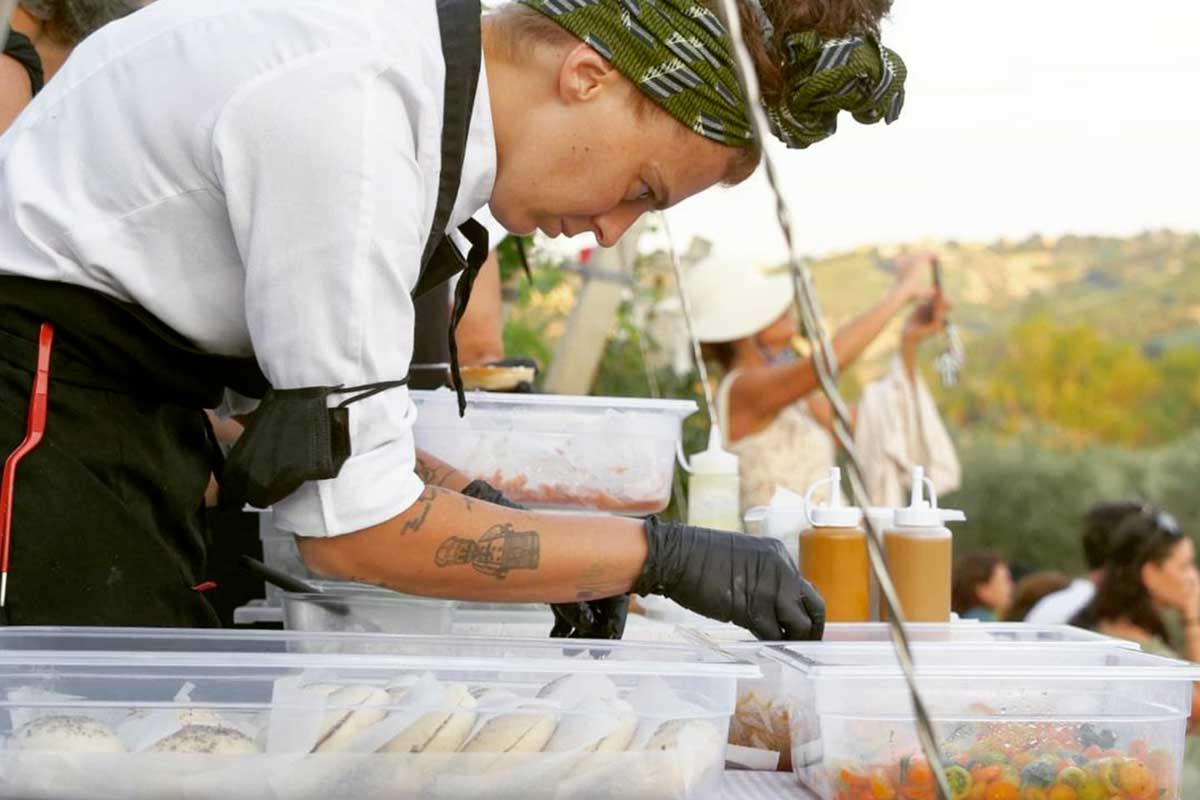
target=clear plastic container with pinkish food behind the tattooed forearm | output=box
[409,390,697,516]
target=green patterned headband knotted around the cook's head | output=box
[520,0,906,148]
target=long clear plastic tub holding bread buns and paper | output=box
[0,631,756,800]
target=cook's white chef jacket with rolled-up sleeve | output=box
[0,0,496,535]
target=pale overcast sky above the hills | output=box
[652,0,1200,263]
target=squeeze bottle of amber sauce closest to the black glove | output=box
[800,467,871,622]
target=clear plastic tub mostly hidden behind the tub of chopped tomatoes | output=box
[680,622,1138,770]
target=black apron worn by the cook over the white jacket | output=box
[0,0,487,627]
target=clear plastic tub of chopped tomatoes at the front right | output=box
[770,642,1200,800]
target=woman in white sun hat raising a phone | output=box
[688,254,958,510]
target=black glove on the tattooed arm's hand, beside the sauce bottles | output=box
[634,517,824,640]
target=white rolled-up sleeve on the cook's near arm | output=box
[212,50,431,536]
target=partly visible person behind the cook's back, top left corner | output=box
[0,0,138,133]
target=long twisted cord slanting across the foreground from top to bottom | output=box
[692,0,953,800]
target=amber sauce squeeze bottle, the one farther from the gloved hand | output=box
[880,467,965,622]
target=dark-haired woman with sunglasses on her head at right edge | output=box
[1070,506,1200,798]
